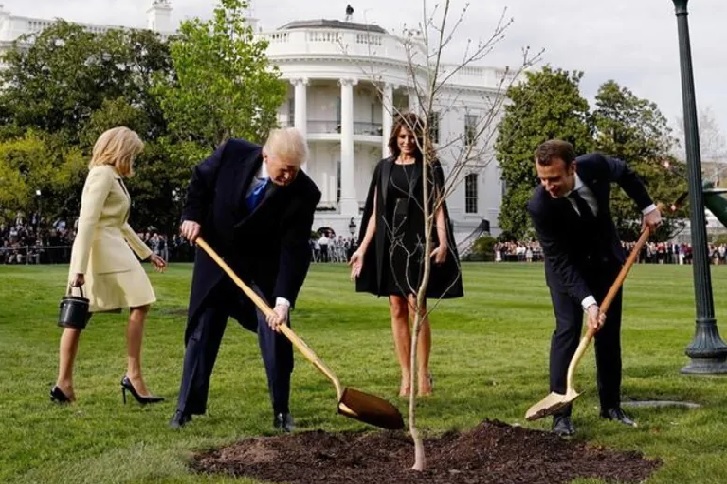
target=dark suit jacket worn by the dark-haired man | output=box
[527,154,653,302]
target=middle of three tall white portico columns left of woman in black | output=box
[338,79,358,217]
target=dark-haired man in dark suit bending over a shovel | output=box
[527,140,661,436]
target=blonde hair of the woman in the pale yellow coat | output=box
[88,126,144,176]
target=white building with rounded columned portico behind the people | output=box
[0,0,508,241]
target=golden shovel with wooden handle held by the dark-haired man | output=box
[525,228,649,420]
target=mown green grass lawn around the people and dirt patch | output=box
[0,263,727,483]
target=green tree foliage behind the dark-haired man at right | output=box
[495,67,686,240]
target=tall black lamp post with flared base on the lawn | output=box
[672,0,727,374]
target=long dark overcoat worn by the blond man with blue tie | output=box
[182,139,321,331]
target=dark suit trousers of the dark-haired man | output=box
[550,272,623,416]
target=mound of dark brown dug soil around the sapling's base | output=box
[192,420,661,484]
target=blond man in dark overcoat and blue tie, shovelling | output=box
[169,128,320,432]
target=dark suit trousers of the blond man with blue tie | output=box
[177,280,293,415]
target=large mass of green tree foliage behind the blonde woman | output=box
[0,0,287,228]
